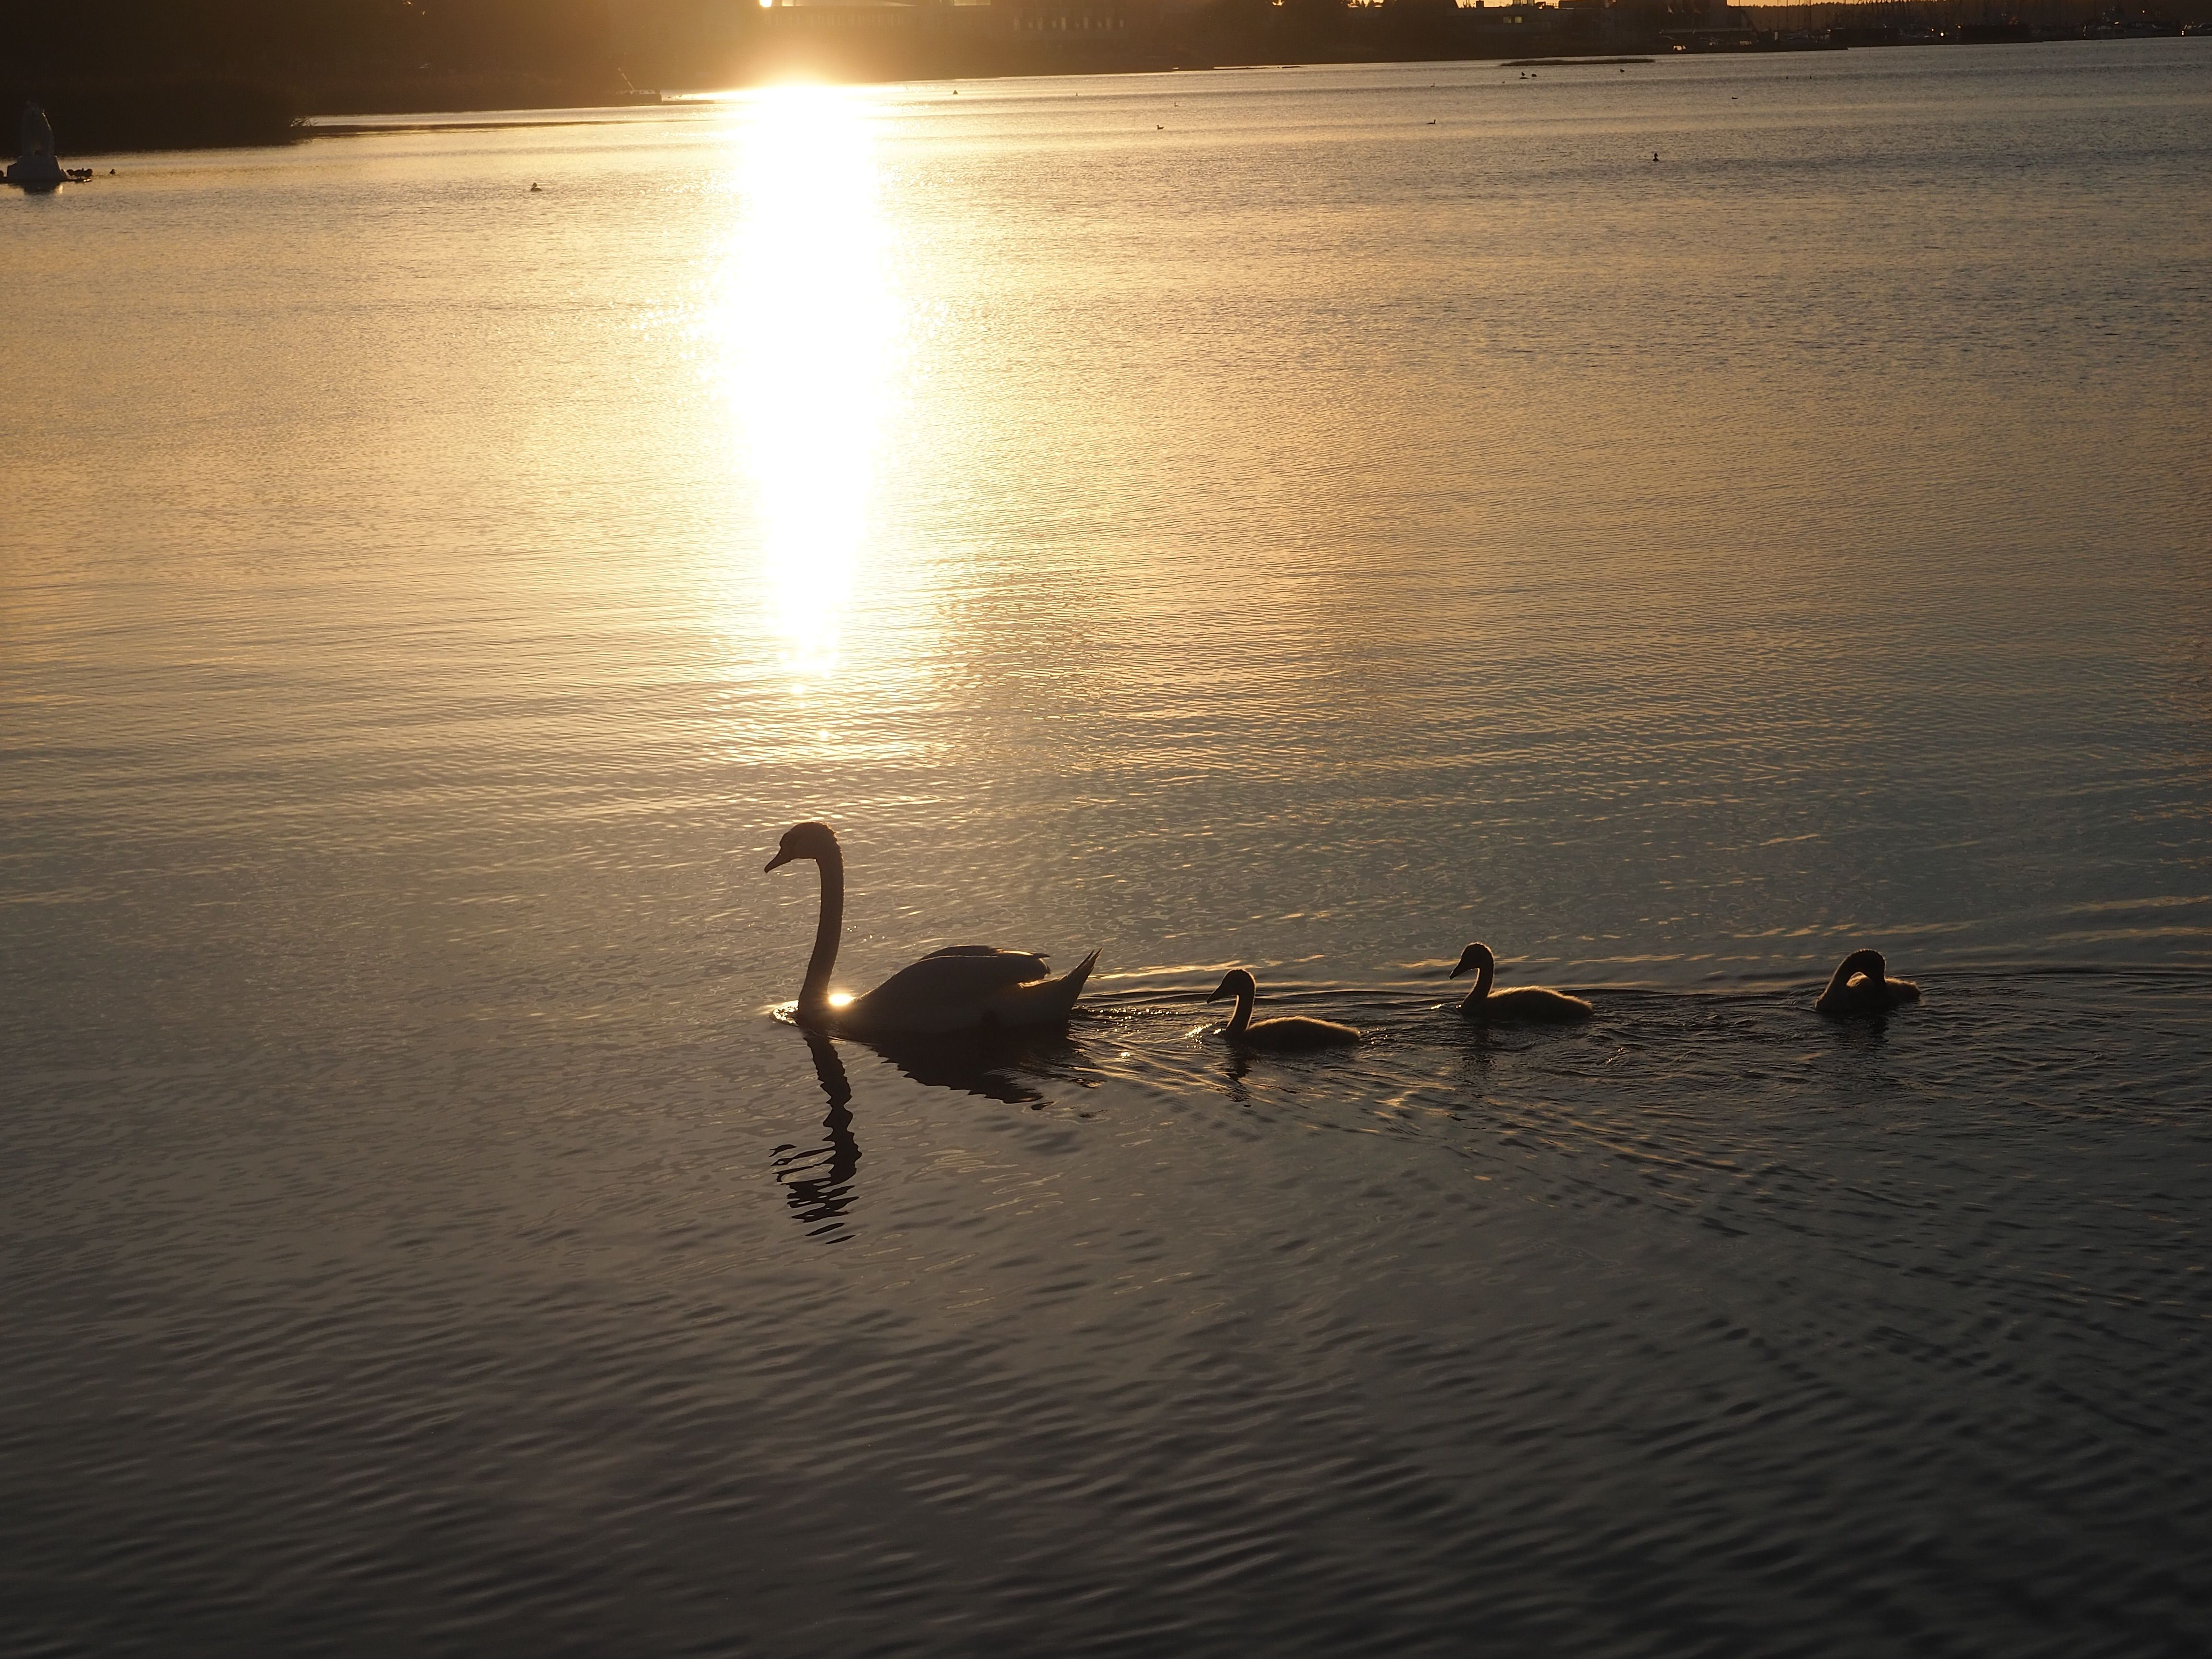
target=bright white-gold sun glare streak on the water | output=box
[712,86,900,697]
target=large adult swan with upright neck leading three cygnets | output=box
[768,823,1099,1037]
